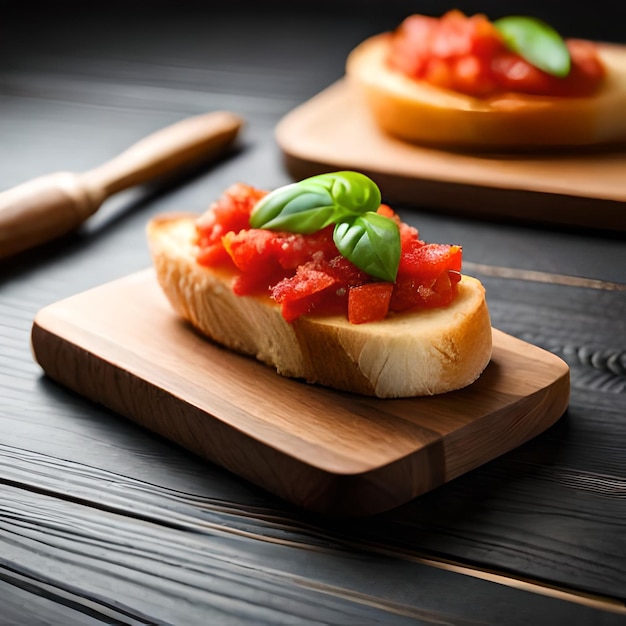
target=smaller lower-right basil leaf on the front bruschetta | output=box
[333,211,401,282]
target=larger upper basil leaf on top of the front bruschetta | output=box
[250,172,381,234]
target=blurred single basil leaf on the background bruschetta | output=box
[494,15,571,78]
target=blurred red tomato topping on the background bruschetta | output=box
[388,10,605,98]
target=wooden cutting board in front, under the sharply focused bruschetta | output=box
[32,269,569,515]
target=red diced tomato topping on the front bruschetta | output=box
[196,184,462,324]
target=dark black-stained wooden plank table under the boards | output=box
[0,2,626,625]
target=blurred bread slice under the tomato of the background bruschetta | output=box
[346,33,626,151]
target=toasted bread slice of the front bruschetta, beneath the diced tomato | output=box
[147,214,491,398]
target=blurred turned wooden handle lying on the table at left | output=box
[0,111,243,259]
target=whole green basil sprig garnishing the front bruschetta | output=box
[250,171,401,282]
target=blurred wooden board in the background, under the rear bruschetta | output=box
[276,79,626,231]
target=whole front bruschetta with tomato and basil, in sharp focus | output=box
[147,172,492,398]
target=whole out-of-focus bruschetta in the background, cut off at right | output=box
[346,10,626,151]
